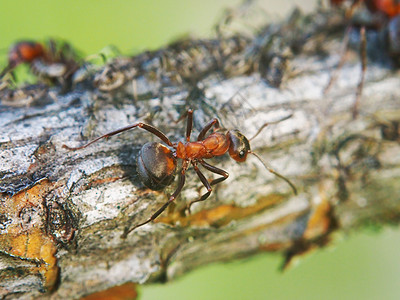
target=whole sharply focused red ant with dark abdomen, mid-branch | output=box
[63,109,297,237]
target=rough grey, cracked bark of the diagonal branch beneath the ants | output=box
[0,7,400,299]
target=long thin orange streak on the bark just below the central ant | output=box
[155,194,284,226]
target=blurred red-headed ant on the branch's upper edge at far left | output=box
[0,40,79,90]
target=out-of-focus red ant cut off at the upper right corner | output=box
[325,0,400,118]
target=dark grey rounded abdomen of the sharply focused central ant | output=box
[137,142,177,191]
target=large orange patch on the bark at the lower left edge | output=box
[0,179,58,290]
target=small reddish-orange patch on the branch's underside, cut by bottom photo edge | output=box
[81,282,138,300]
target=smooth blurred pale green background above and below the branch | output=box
[0,0,400,300]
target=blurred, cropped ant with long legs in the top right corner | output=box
[325,0,400,118]
